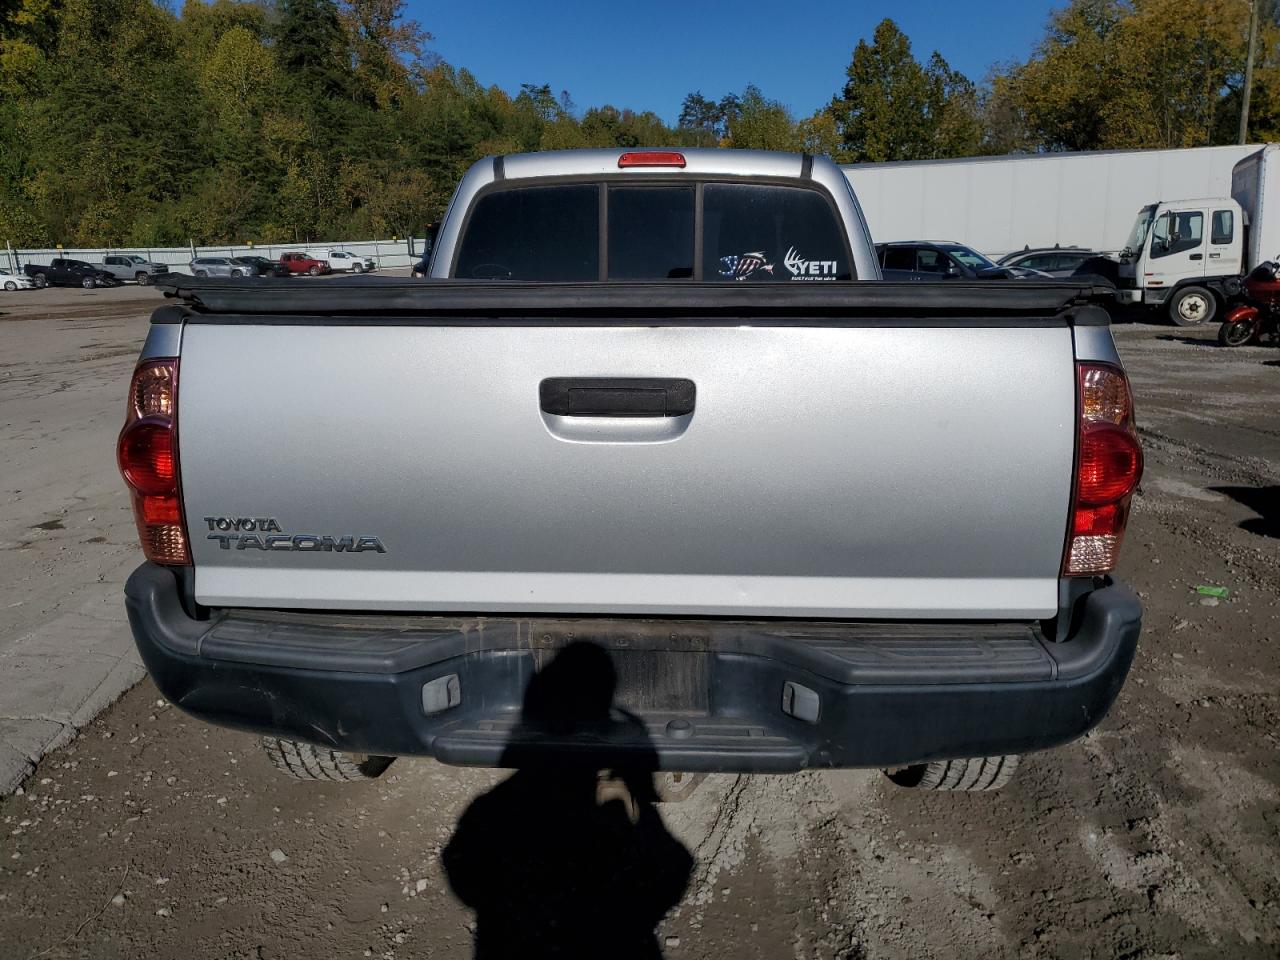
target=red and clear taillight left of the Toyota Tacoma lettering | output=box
[115,358,191,566]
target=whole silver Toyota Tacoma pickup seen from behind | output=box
[118,150,1142,790]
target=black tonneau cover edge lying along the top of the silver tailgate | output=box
[152,274,1114,326]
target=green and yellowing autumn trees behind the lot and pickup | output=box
[0,0,1280,247]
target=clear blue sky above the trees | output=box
[408,0,1065,122]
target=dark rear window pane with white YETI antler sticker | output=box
[703,183,852,283]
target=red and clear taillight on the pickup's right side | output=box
[1062,364,1142,576]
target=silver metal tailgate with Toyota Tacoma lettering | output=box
[178,327,1080,620]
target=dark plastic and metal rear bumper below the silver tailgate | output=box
[125,564,1142,772]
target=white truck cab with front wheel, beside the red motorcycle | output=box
[1117,197,1244,326]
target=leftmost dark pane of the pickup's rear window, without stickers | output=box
[454,183,600,282]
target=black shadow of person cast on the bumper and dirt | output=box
[443,643,694,960]
